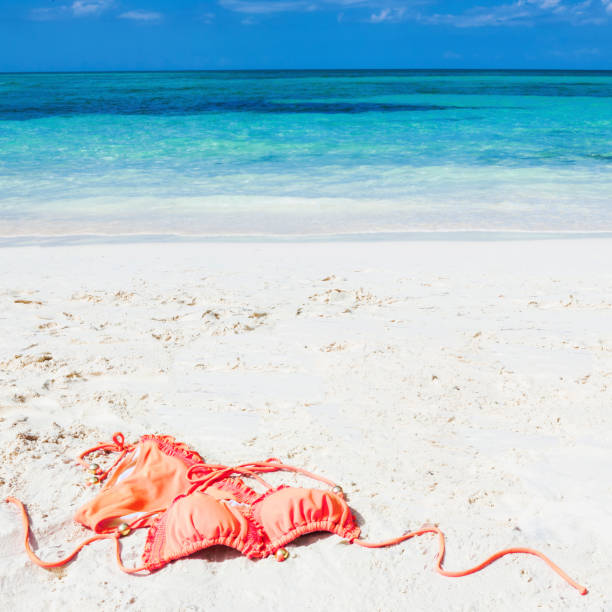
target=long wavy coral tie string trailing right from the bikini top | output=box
[349,525,588,595]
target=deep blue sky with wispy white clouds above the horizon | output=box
[0,0,612,71]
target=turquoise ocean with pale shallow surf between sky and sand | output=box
[0,70,612,240]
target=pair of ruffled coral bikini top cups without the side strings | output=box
[143,461,359,570]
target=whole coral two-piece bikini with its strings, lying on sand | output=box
[6,434,587,595]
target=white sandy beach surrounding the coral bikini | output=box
[0,240,612,611]
